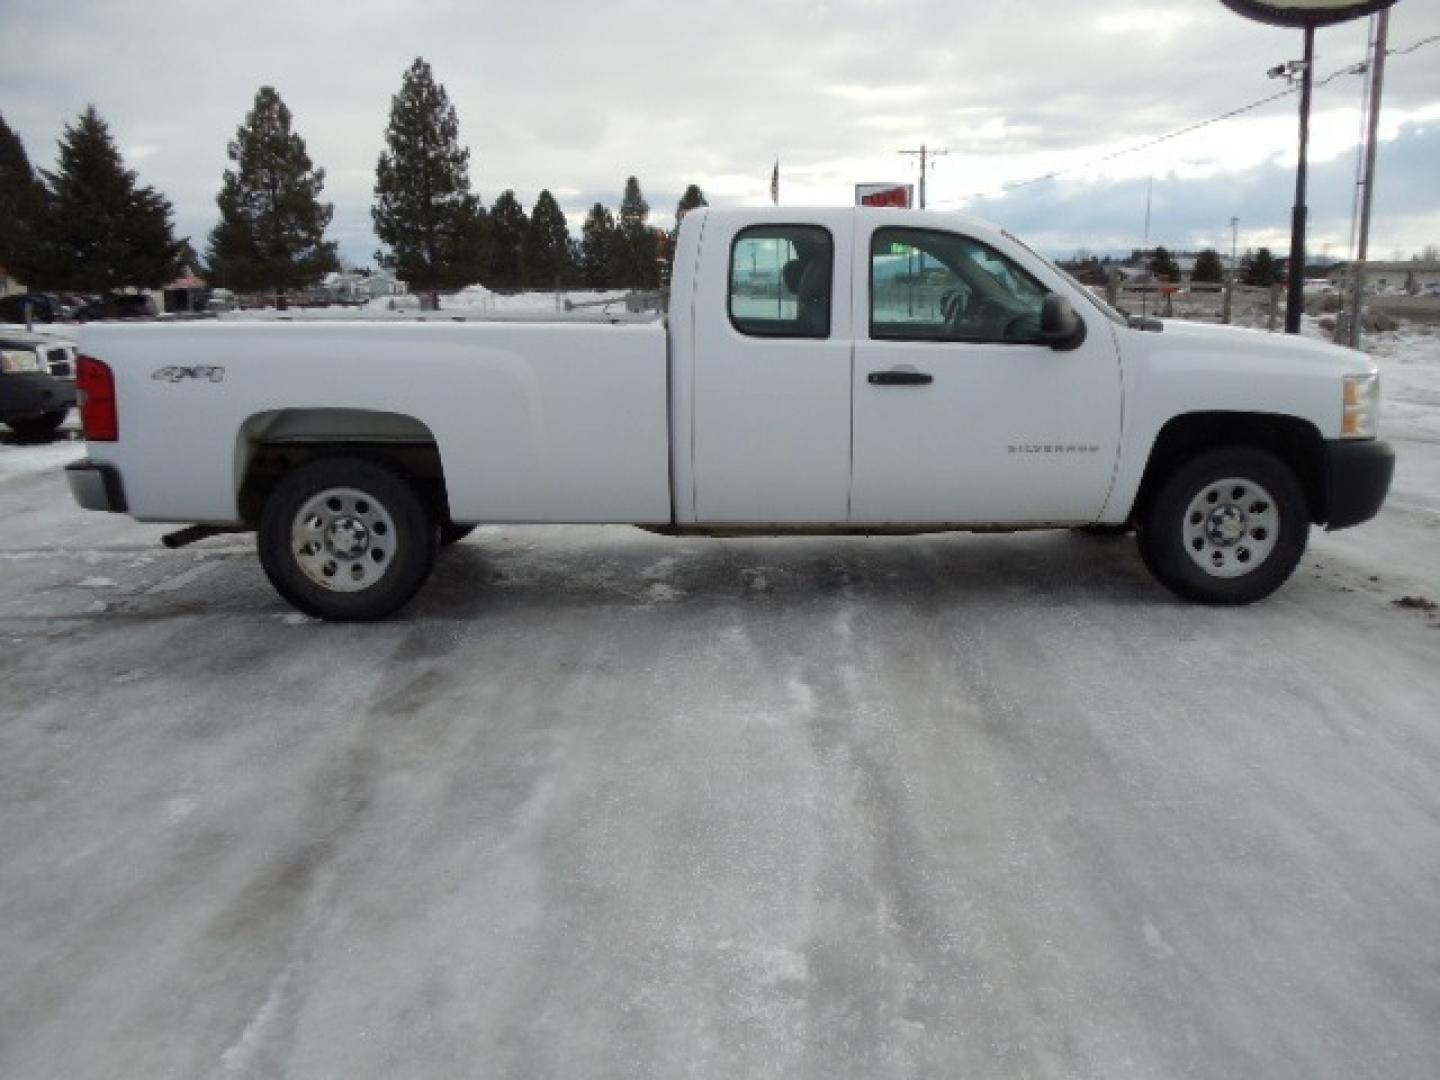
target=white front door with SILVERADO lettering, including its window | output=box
[851,219,1120,524]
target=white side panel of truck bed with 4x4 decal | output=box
[81,312,671,524]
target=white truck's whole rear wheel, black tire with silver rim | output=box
[258,458,439,622]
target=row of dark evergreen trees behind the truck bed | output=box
[0,59,706,297]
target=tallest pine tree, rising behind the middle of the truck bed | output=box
[370,58,485,305]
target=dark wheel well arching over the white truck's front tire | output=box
[1130,412,1326,524]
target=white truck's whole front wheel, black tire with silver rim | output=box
[1139,446,1310,603]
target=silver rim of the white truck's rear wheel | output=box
[289,488,397,592]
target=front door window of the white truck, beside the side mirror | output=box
[870,229,1048,344]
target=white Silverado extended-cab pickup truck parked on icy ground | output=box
[68,207,1394,619]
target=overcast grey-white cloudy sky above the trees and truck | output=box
[0,0,1440,264]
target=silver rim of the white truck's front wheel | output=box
[1182,477,1280,577]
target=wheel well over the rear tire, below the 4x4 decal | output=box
[235,409,449,527]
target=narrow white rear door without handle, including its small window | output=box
[680,212,851,526]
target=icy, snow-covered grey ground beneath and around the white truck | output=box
[0,331,1440,1080]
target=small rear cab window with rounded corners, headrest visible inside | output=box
[730,225,835,337]
